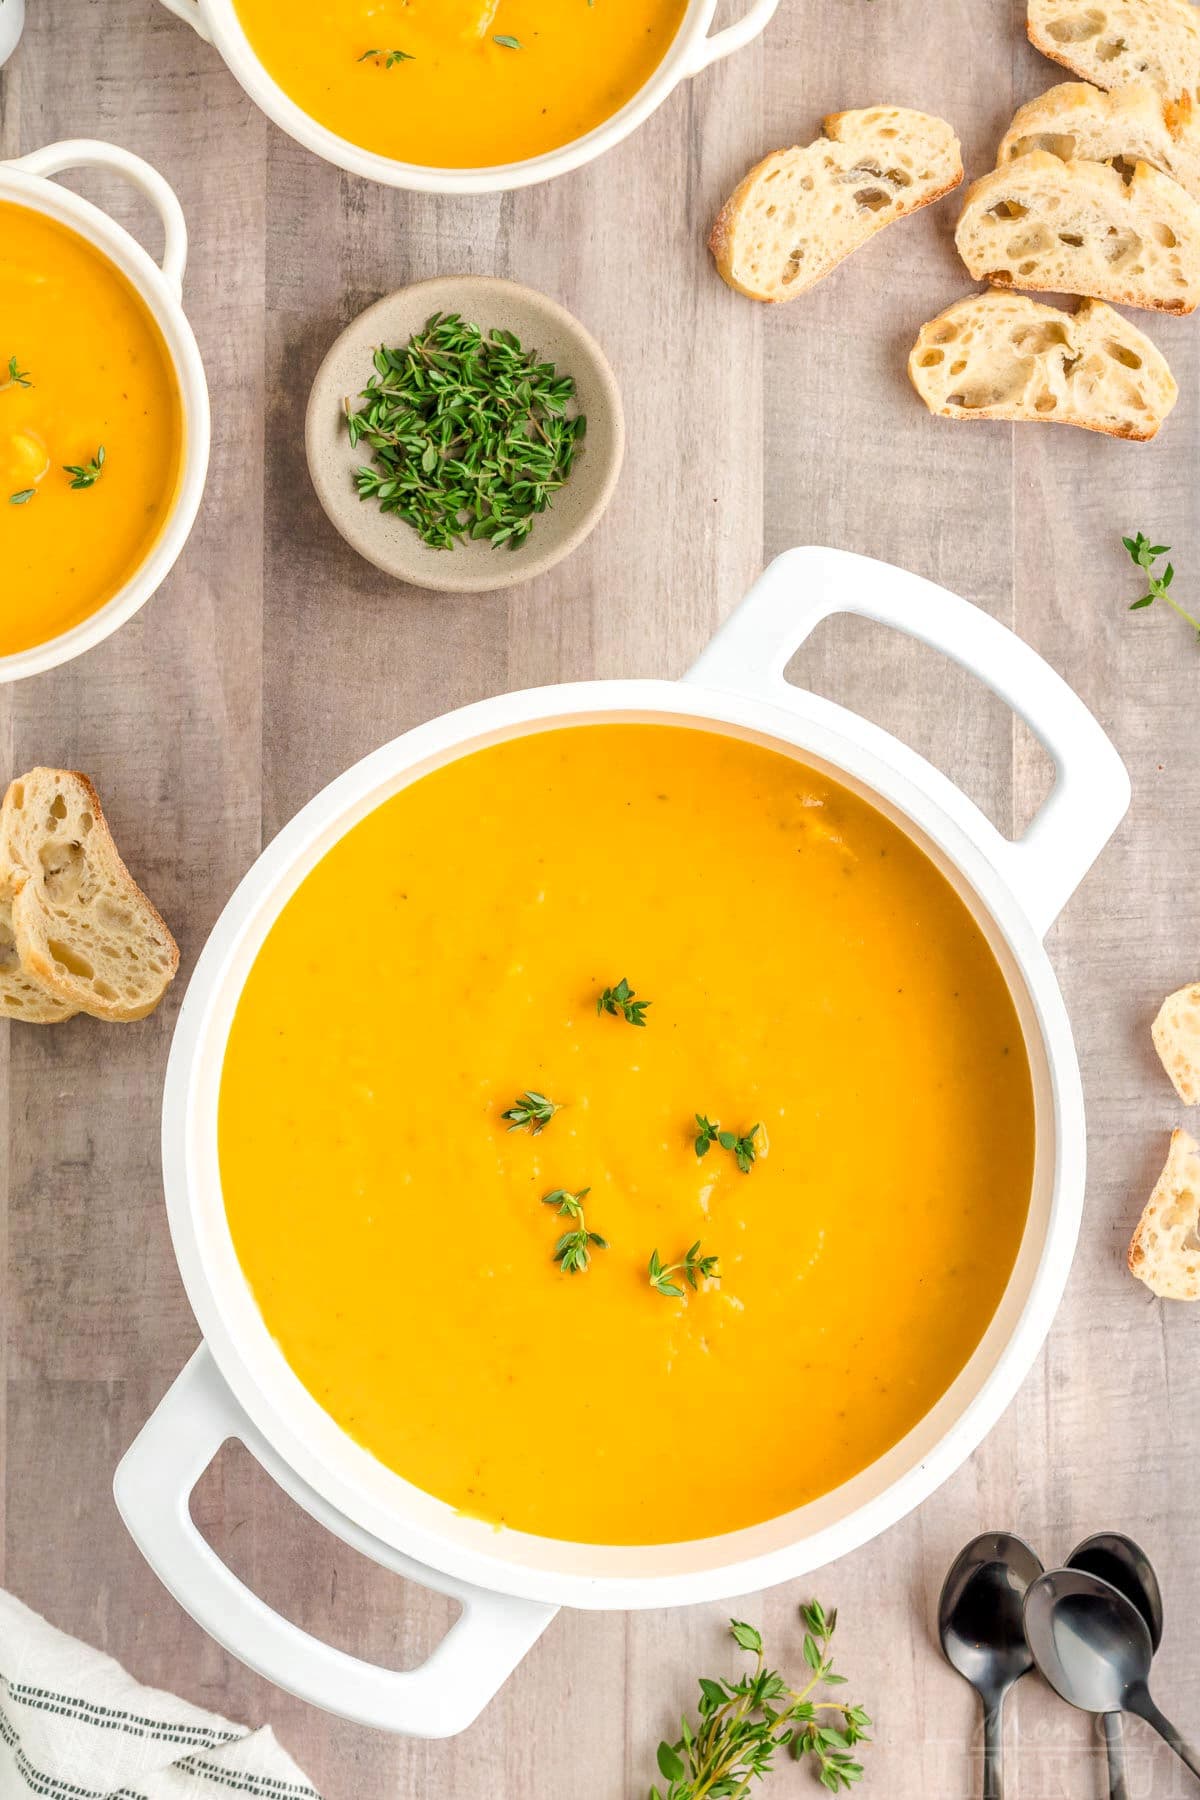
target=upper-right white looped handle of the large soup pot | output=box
[687,549,1130,934]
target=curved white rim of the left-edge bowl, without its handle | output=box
[0,144,212,682]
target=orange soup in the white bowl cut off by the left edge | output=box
[0,202,184,655]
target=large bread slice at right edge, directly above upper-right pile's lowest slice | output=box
[954,149,1200,313]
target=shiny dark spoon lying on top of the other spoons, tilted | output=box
[1025,1570,1200,1775]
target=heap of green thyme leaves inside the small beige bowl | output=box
[345,313,587,551]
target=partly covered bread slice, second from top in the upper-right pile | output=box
[997,81,1195,198]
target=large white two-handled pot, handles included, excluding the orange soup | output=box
[115,549,1130,1737]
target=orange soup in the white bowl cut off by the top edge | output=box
[237,0,685,169]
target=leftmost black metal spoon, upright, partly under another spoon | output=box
[937,1532,1042,1800]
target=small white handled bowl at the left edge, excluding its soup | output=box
[0,139,210,682]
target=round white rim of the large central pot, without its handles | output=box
[164,680,1085,1607]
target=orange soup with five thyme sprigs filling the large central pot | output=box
[219,724,1034,1544]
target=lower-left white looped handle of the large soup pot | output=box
[113,1345,556,1737]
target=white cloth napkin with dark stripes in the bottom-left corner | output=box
[0,1591,320,1800]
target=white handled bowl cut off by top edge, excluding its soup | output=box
[152,0,779,194]
